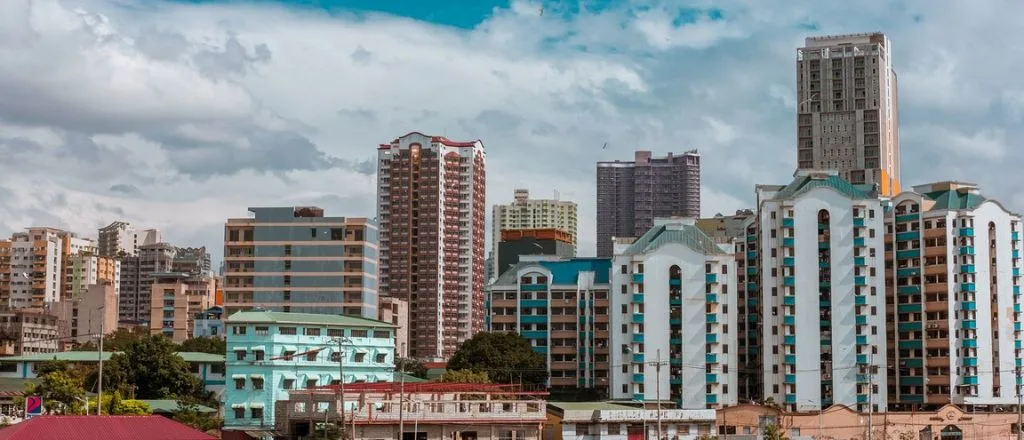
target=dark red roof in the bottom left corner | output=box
[0,415,216,440]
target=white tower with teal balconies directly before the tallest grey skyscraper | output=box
[757,170,887,411]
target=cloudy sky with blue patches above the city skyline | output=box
[0,0,1024,260]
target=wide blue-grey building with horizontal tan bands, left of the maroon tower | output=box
[222,207,377,319]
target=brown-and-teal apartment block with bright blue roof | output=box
[489,257,611,390]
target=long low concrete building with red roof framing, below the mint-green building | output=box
[274,383,548,440]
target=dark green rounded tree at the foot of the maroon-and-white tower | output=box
[447,333,548,385]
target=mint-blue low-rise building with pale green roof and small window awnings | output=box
[224,310,395,431]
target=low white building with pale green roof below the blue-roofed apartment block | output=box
[545,402,716,440]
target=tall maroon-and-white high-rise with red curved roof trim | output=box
[377,132,486,358]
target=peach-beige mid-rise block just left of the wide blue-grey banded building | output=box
[150,272,216,343]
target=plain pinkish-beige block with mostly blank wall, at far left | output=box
[51,280,118,344]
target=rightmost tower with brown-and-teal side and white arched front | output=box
[886,182,1024,409]
